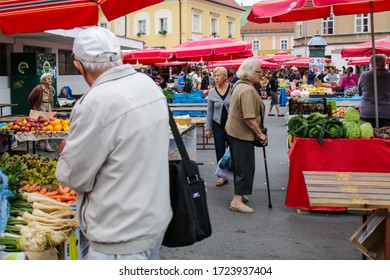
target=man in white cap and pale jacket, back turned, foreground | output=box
[56,27,172,260]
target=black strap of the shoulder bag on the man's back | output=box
[168,108,199,184]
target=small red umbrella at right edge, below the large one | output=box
[341,37,390,58]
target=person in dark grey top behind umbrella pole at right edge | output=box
[358,54,390,127]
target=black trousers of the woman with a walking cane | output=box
[229,136,255,195]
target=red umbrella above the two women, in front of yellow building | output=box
[161,37,253,61]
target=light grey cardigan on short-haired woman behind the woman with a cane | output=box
[205,84,233,130]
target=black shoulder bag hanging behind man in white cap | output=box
[162,110,211,247]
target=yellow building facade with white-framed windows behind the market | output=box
[99,0,244,48]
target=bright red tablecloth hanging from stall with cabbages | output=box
[285,138,390,211]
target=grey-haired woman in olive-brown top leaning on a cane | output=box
[226,58,268,214]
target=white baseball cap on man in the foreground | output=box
[73,26,121,62]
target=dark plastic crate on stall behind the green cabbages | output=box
[288,98,327,115]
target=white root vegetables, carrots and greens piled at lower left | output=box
[0,153,78,252]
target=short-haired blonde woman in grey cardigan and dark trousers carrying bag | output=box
[205,67,232,186]
